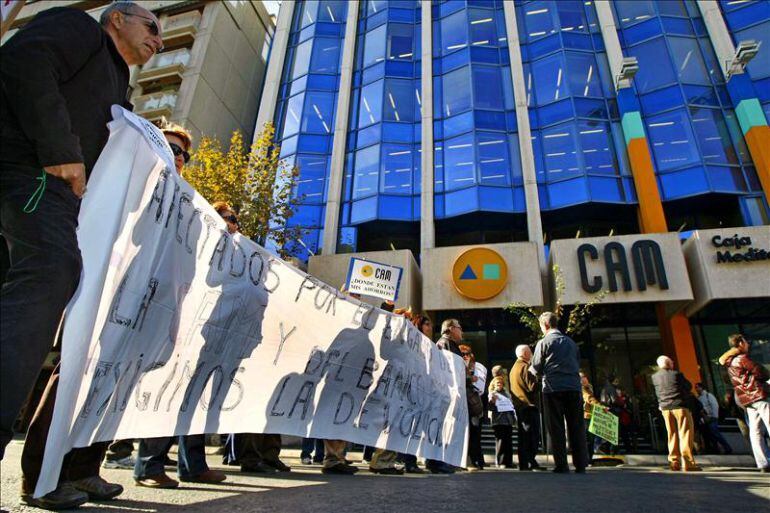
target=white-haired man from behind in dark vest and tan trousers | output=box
[652,355,702,472]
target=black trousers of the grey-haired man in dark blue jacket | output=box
[543,390,588,470]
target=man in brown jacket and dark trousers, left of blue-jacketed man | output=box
[510,344,545,471]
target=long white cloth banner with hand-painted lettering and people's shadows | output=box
[35,107,468,496]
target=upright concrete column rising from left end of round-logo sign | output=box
[420,2,436,251]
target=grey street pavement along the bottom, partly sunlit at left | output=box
[0,441,770,513]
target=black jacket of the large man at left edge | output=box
[0,7,130,173]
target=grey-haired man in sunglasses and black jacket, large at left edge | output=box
[0,2,162,508]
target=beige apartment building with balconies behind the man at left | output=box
[3,0,275,142]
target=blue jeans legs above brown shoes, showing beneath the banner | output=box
[134,435,209,479]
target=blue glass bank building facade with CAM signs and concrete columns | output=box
[257,0,770,436]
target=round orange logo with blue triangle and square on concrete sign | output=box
[452,248,508,301]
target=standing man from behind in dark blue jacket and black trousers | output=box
[530,312,588,474]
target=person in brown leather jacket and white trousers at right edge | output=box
[719,334,770,472]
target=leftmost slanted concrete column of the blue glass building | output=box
[253,0,295,140]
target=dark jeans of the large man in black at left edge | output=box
[0,163,82,459]
